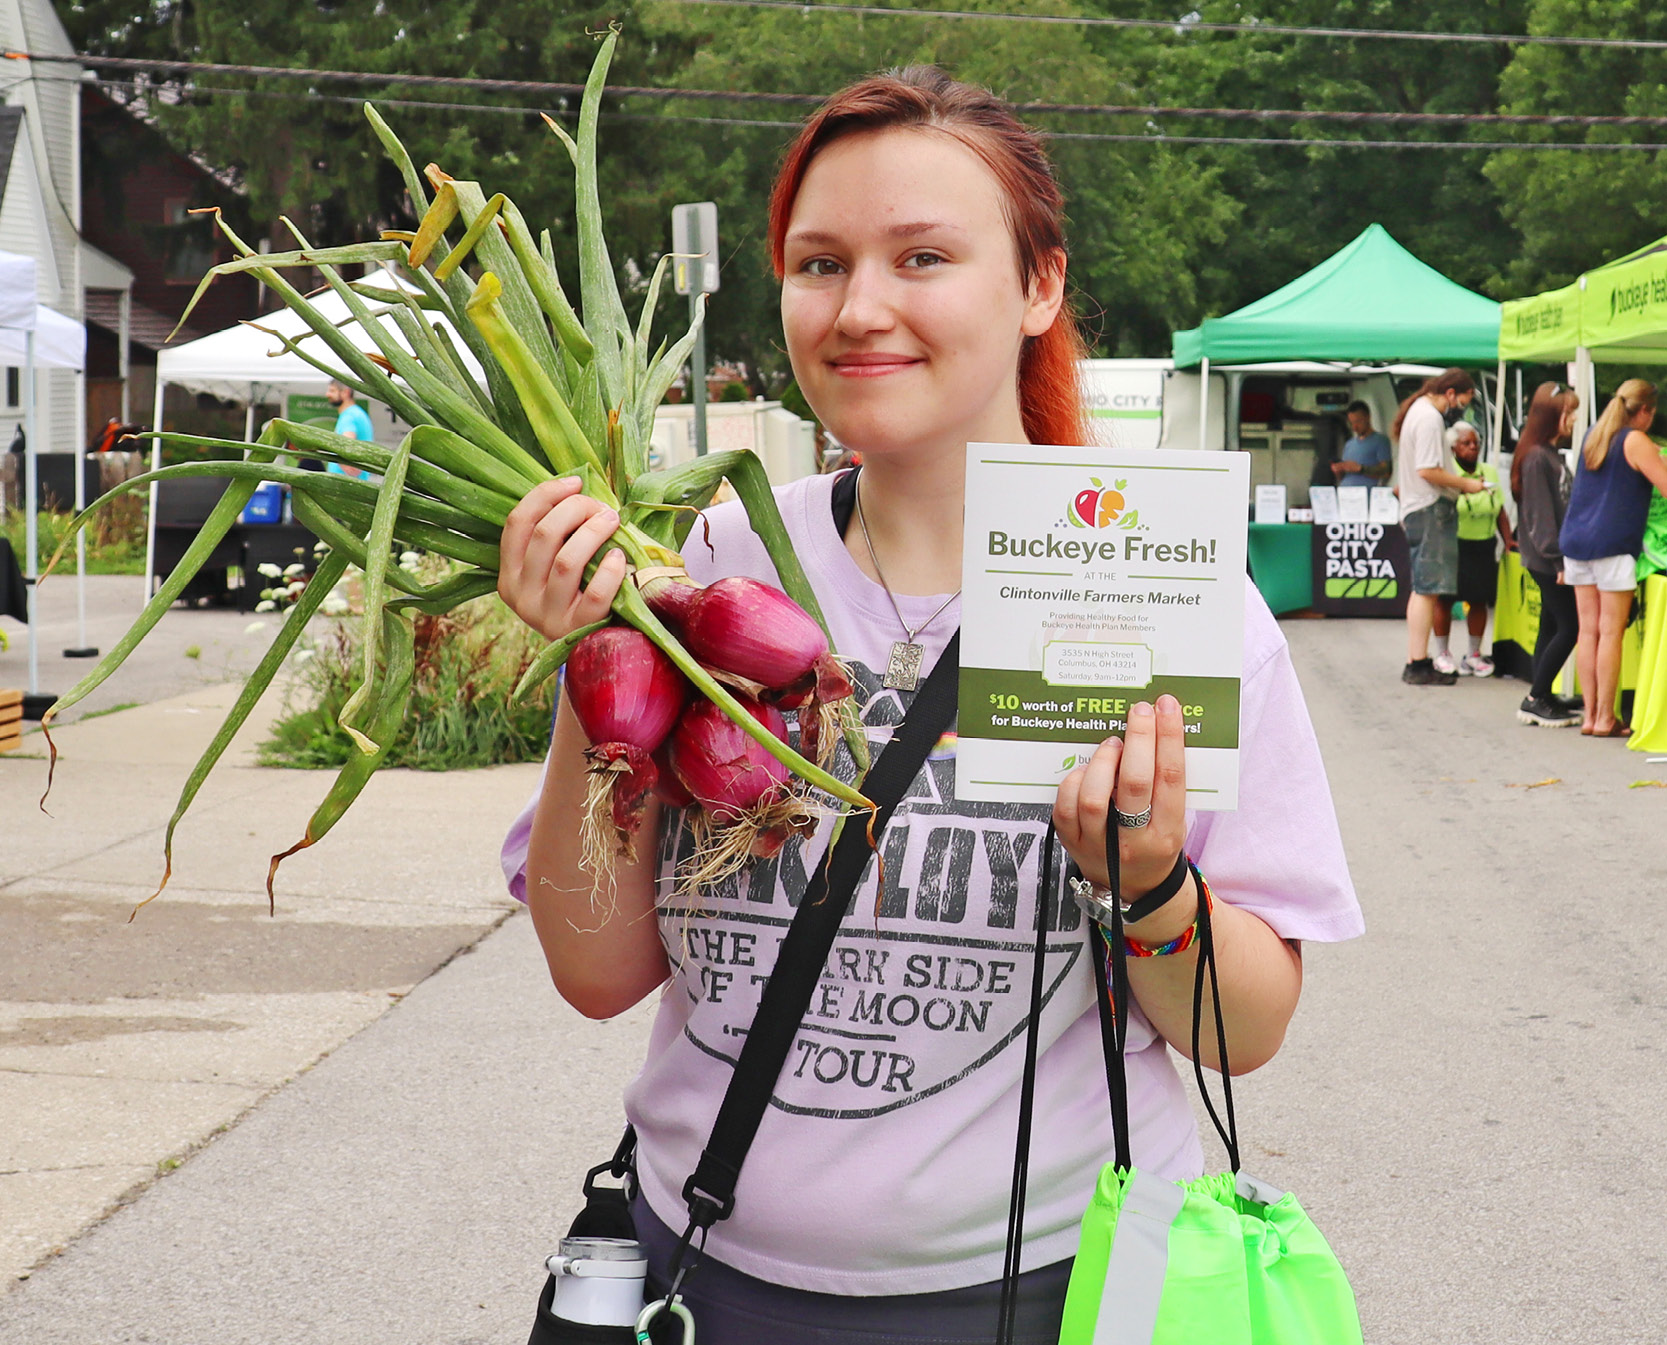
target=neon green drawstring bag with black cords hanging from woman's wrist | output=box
[1015,826,1360,1345]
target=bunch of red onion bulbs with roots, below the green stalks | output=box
[565,578,852,882]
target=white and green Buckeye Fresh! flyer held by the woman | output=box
[955,443,1250,810]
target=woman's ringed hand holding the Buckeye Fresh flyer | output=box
[1054,695,1187,903]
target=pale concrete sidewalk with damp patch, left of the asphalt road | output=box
[0,683,537,1287]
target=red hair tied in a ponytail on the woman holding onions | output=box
[770,65,1089,443]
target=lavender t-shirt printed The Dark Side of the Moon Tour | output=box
[503,477,1362,1295]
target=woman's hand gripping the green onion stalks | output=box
[498,477,625,640]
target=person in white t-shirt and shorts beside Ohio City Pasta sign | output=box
[1390,368,1487,687]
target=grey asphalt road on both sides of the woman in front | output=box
[0,620,1667,1345]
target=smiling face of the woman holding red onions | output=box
[782,130,1064,455]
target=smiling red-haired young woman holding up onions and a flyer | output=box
[502,60,1360,1345]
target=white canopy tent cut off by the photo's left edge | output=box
[0,252,87,697]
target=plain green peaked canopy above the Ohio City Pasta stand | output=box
[1174,223,1499,442]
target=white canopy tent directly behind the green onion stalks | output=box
[145,283,487,602]
